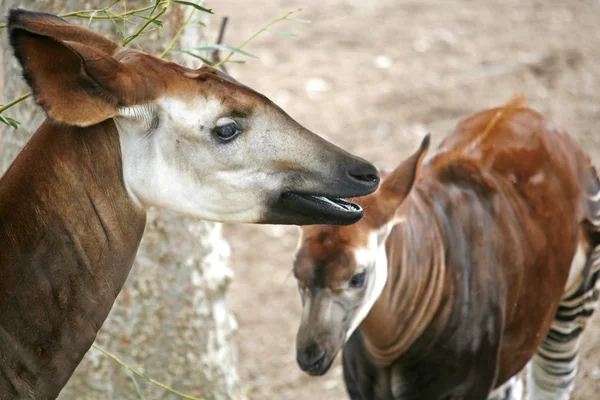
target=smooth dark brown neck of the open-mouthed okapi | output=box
[0,120,146,398]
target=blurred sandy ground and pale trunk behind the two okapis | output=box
[0,0,600,400]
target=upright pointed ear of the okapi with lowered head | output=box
[380,134,431,218]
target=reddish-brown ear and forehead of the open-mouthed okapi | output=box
[9,8,268,126]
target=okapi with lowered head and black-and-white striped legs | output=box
[294,98,600,400]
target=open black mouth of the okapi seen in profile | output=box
[279,192,363,225]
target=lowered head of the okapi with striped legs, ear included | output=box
[294,135,429,375]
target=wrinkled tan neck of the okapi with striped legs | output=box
[360,192,448,367]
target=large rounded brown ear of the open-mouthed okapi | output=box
[8,10,157,126]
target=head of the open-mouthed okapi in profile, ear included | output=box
[8,10,379,225]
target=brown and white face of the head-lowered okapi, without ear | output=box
[295,224,391,375]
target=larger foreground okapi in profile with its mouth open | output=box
[0,10,379,399]
